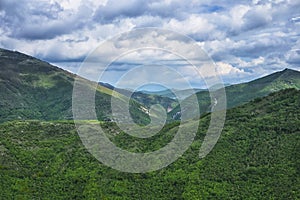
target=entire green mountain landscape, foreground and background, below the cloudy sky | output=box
[0,49,300,199]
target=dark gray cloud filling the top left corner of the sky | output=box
[0,0,90,40]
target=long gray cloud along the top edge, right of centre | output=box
[94,0,225,23]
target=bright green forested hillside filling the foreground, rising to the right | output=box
[0,89,300,200]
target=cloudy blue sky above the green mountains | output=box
[0,0,300,87]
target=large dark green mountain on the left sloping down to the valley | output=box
[0,49,150,123]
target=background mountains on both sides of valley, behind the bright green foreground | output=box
[0,49,300,124]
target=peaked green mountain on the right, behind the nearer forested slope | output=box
[168,69,300,119]
